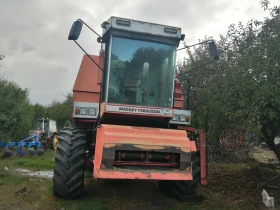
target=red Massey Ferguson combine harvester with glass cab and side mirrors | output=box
[53,17,219,199]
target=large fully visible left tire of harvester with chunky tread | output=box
[53,128,86,199]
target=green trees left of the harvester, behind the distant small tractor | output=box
[0,75,73,141]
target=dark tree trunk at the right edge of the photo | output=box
[262,126,280,162]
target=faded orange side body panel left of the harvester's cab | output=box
[73,52,104,103]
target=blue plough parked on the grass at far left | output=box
[0,134,45,156]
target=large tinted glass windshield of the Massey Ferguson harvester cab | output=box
[108,37,176,107]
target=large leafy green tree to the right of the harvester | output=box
[180,1,280,160]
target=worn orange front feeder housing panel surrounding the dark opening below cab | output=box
[93,124,196,180]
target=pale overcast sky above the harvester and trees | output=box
[0,0,279,105]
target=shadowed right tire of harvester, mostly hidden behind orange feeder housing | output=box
[159,153,200,198]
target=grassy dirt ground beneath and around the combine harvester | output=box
[0,148,280,210]
